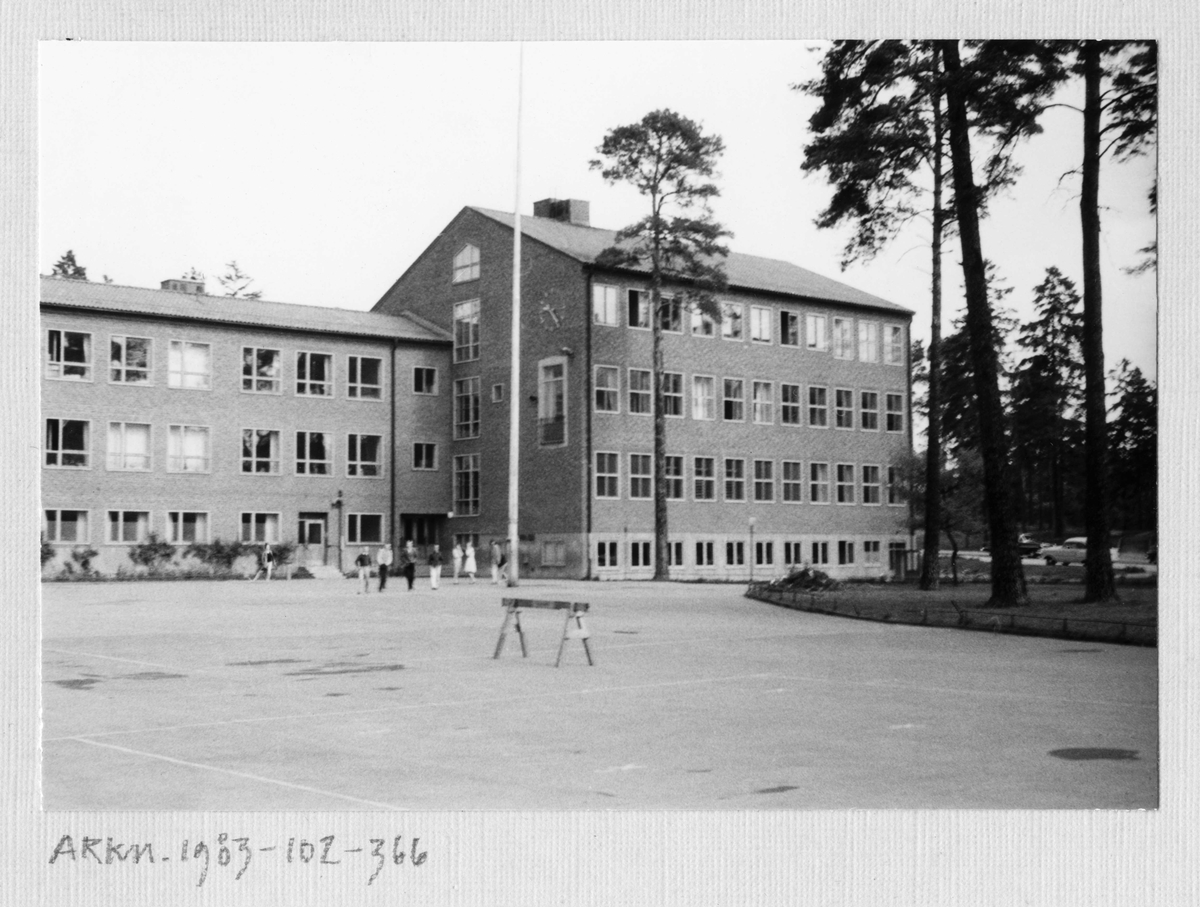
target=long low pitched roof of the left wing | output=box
[41,277,451,341]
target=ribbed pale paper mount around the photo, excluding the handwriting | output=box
[0,0,1200,907]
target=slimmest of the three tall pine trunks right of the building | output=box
[920,47,946,590]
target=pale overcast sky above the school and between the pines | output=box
[38,42,1156,376]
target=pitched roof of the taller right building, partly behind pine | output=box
[470,206,912,314]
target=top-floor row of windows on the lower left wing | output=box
[46,328,438,400]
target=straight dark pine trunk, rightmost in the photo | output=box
[1079,41,1117,601]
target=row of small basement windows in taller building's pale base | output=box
[595,539,905,570]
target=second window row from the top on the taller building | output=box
[592,365,905,432]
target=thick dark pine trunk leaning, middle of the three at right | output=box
[938,41,1028,607]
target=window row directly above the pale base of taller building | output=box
[595,451,904,506]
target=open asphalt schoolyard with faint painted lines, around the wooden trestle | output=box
[41,578,1158,811]
